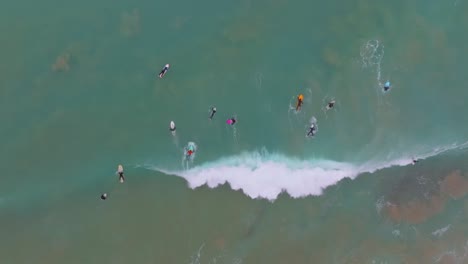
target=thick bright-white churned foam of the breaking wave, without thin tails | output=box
[186,154,356,200]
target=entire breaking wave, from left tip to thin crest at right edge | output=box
[153,143,467,200]
